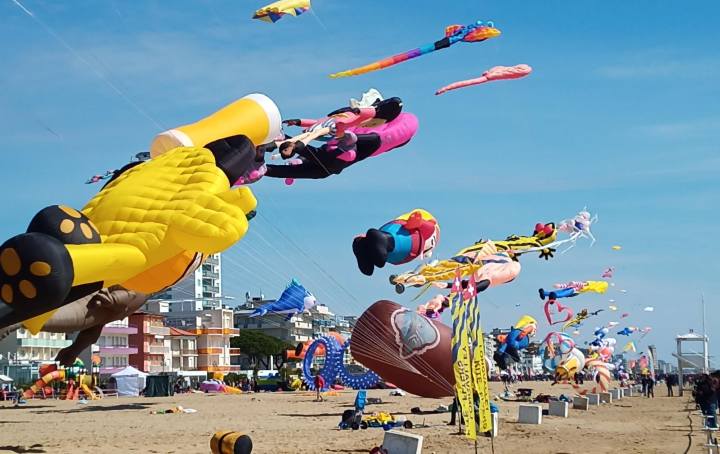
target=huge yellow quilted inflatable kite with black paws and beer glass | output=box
[0,95,280,331]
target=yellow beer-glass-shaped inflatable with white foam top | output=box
[150,93,282,158]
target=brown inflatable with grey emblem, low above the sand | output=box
[352,300,455,398]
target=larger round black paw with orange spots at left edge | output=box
[0,232,73,310]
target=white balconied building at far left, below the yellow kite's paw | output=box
[0,328,71,363]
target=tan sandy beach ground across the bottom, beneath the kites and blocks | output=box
[0,382,707,454]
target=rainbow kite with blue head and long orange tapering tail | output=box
[330,21,500,79]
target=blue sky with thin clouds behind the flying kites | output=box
[0,0,720,359]
